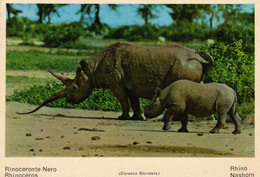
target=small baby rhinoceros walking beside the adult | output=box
[144,80,241,134]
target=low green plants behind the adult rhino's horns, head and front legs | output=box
[6,82,148,111]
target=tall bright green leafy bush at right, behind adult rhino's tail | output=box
[202,40,255,103]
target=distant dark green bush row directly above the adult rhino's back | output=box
[105,21,210,42]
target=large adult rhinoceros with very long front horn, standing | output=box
[17,42,214,120]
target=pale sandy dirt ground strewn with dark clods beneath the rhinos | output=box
[5,102,255,157]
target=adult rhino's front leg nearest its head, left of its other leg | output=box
[110,83,130,120]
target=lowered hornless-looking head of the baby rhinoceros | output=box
[144,88,163,118]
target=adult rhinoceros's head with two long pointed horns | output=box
[18,66,93,114]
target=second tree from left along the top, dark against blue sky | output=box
[37,4,66,23]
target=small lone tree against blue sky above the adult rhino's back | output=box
[137,4,158,25]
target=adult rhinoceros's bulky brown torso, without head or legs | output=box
[92,42,202,98]
